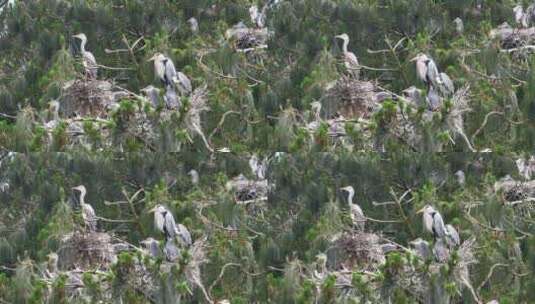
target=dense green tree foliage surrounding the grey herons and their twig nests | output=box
[0,0,535,303]
